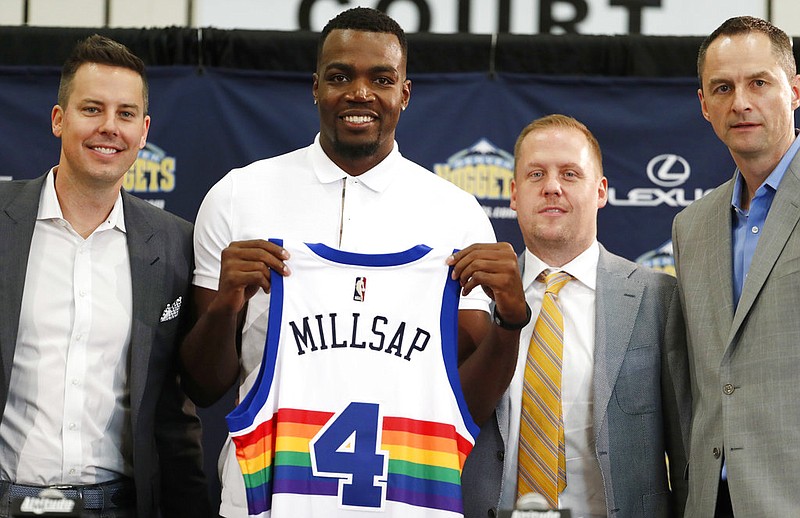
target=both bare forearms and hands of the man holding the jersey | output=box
[181,240,526,424]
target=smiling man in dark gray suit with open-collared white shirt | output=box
[0,36,210,517]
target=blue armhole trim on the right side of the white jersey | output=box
[441,249,481,440]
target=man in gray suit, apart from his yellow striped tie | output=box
[463,115,691,518]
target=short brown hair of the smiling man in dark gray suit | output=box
[58,34,149,115]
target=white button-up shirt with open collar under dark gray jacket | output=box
[0,170,133,485]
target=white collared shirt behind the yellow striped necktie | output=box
[500,241,606,518]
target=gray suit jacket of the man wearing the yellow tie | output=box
[462,245,691,518]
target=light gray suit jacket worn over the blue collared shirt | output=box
[672,149,800,517]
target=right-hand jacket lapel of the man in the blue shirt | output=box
[725,164,800,350]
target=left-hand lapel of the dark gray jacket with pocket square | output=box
[0,175,47,416]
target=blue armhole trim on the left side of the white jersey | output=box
[225,239,283,432]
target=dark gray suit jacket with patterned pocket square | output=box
[0,176,210,516]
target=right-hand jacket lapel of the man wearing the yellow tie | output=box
[592,245,644,439]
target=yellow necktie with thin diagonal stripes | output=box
[517,270,572,509]
